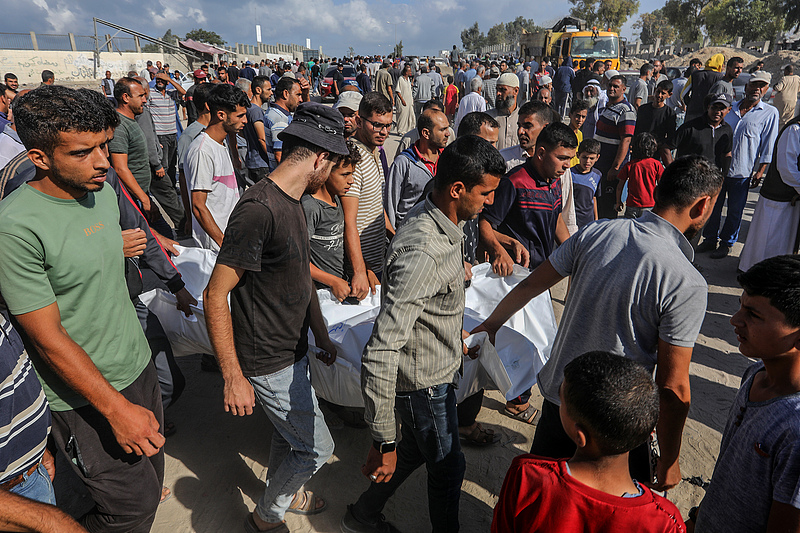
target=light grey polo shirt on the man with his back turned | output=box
[539,212,708,404]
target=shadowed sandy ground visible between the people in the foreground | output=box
[57,130,757,533]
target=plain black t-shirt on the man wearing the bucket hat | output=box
[217,180,316,377]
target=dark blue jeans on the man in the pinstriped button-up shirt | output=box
[353,384,466,533]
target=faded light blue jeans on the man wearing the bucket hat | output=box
[247,357,333,523]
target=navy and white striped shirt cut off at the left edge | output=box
[0,313,50,483]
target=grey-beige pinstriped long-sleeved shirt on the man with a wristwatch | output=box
[361,196,464,441]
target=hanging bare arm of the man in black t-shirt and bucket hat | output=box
[203,263,256,416]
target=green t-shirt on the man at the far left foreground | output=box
[0,184,150,411]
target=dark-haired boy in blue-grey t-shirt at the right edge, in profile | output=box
[686,255,800,533]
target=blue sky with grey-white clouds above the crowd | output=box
[6,0,664,56]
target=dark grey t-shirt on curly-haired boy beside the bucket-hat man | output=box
[300,190,344,282]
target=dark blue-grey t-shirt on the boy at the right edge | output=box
[695,361,800,533]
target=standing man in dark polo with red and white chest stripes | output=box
[594,75,636,218]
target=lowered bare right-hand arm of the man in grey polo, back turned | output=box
[654,339,692,490]
